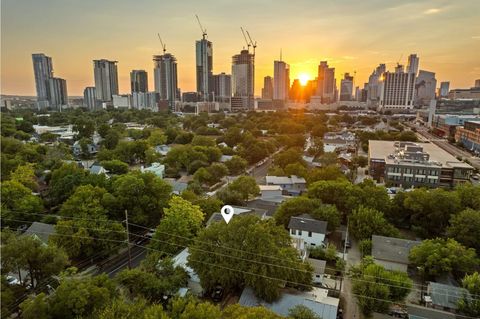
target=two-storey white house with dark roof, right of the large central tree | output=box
[288,214,327,251]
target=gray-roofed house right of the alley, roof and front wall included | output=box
[372,235,421,272]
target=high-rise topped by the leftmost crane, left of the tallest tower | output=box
[153,53,180,111]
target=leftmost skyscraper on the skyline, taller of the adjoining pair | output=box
[32,53,53,108]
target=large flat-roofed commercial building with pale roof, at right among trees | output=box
[368,140,473,188]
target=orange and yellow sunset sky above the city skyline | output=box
[1,0,480,96]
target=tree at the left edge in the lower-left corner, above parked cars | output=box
[1,236,68,287]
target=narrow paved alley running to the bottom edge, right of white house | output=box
[342,239,362,319]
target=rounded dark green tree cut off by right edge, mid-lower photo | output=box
[447,208,480,251]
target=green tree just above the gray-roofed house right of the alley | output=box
[349,206,399,240]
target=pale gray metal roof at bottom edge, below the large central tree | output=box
[238,287,339,319]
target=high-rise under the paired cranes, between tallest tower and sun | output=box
[232,50,255,109]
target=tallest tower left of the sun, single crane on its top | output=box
[196,38,213,101]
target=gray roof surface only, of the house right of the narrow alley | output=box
[372,235,421,265]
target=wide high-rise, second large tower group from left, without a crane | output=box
[93,59,118,102]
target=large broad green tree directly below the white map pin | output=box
[188,215,312,301]
